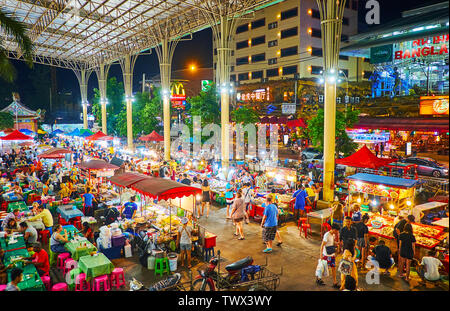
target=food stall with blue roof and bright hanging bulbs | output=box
[346,173,418,216]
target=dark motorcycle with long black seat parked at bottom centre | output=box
[192,251,253,291]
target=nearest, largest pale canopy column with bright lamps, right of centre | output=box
[316,0,345,202]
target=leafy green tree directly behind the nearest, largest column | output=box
[307,109,359,156]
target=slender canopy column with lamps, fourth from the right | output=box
[119,54,138,149]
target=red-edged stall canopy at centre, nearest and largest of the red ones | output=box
[131,177,202,200]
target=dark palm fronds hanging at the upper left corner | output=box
[0,8,33,82]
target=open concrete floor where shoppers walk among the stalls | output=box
[47,202,448,291]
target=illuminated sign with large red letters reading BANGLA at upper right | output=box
[394,34,449,60]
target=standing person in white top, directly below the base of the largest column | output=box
[316,224,339,288]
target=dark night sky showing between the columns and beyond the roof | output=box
[2,0,442,114]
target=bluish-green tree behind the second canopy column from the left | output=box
[92,77,126,135]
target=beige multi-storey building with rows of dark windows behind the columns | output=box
[214,0,371,84]
